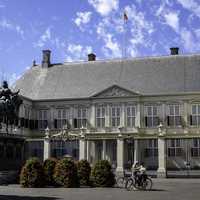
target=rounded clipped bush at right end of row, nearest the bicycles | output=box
[92,160,115,187]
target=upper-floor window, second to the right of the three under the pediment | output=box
[167,104,181,126]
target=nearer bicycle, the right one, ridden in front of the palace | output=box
[125,174,153,191]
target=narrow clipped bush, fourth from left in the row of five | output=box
[77,160,91,186]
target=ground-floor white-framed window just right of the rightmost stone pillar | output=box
[168,139,182,157]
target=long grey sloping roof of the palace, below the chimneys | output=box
[16,55,200,100]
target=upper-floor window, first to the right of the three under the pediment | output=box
[145,105,159,127]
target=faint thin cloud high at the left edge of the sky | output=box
[0,18,24,37]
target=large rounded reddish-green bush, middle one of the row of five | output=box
[53,158,79,187]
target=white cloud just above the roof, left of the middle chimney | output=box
[65,44,92,62]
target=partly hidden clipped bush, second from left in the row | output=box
[43,158,58,186]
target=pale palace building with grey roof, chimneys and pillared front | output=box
[16,48,200,177]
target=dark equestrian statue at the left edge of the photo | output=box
[0,81,23,133]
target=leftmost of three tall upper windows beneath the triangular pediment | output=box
[96,106,106,128]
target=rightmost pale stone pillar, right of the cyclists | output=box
[157,137,166,178]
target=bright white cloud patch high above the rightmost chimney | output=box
[164,12,179,32]
